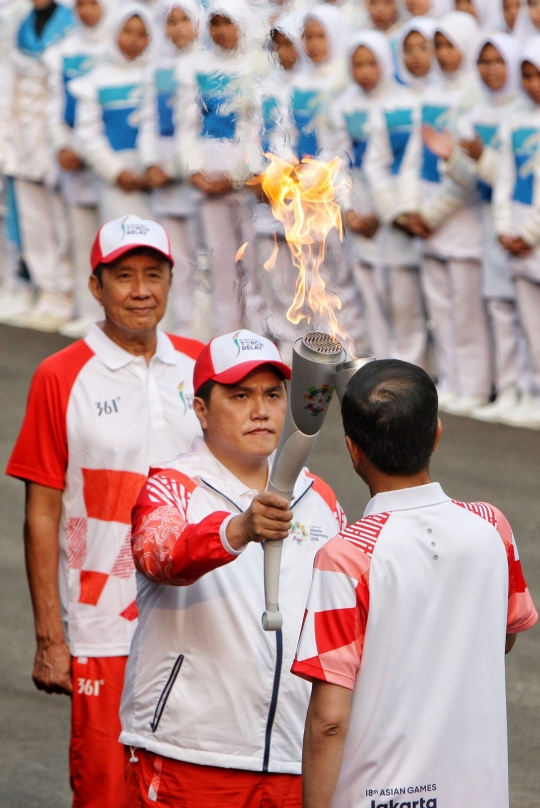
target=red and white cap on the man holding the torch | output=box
[193,329,291,393]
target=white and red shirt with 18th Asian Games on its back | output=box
[292,483,538,808]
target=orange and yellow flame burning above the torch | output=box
[255,154,352,347]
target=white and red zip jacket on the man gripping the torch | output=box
[120,439,345,774]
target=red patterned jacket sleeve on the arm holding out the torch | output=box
[131,469,237,586]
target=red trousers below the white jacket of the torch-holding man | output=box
[126,747,302,808]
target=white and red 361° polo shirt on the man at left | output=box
[7,324,202,657]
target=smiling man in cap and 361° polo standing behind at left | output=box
[7,216,202,808]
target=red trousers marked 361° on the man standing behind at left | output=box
[69,657,127,808]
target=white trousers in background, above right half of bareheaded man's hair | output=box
[388,266,427,367]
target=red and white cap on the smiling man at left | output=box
[90,214,174,272]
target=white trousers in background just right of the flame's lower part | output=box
[353,261,390,359]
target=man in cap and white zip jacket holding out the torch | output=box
[121,331,345,808]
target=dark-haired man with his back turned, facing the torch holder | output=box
[292,360,538,808]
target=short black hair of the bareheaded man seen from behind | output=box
[341,359,439,477]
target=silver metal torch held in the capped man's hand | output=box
[262,332,347,631]
